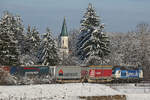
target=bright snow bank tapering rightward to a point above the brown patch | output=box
[0,83,122,100]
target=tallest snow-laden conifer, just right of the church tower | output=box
[77,4,110,65]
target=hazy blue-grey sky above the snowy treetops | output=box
[0,0,150,34]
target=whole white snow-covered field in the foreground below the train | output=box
[0,83,150,100]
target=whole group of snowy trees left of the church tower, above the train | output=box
[0,11,59,66]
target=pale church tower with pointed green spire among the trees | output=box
[59,18,69,55]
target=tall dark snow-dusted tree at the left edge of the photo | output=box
[0,12,22,65]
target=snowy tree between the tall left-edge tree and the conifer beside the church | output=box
[21,25,41,65]
